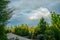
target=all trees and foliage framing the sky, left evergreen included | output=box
[0,0,60,40]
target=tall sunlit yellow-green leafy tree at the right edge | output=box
[51,12,60,40]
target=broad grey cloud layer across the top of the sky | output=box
[9,0,60,14]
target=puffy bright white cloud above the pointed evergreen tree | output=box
[28,7,50,20]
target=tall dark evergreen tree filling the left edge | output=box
[0,0,12,40]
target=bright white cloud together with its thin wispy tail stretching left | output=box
[12,7,50,20]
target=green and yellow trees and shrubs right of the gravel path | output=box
[5,12,60,40]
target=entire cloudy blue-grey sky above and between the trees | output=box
[7,0,60,26]
